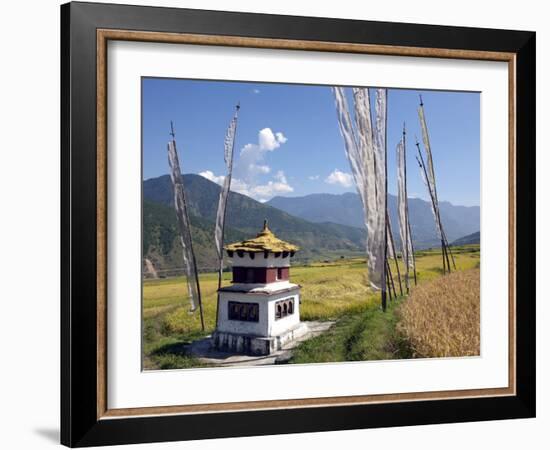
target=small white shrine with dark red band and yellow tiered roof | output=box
[212,220,307,355]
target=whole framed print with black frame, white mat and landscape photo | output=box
[61,3,535,446]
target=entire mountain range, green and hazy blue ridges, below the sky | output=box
[143,174,479,271]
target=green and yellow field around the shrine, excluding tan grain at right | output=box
[142,246,479,369]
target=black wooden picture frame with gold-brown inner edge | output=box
[61,3,536,446]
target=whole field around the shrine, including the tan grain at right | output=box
[142,246,480,369]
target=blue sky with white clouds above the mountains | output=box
[142,78,480,206]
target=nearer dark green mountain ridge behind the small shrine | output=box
[143,174,365,270]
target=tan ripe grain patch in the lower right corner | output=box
[397,269,479,357]
